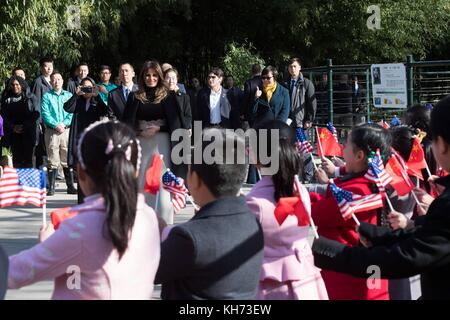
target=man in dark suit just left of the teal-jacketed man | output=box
[31,57,53,168]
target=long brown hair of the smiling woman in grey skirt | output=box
[135,60,169,103]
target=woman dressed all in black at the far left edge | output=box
[0,76,40,168]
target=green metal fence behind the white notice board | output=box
[302,56,450,135]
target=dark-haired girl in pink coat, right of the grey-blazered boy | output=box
[246,120,328,300]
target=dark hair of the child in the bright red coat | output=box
[350,123,391,163]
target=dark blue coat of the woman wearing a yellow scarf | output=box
[250,83,291,126]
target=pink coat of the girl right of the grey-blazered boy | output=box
[247,177,328,299]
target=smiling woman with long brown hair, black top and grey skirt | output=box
[122,61,183,224]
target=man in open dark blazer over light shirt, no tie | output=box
[197,68,241,129]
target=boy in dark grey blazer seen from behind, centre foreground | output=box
[155,128,264,300]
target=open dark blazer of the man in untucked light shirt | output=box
[196,88,241,129]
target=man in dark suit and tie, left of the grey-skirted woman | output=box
[108,63,138,120]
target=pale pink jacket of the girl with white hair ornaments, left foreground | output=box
[8,194,160,299]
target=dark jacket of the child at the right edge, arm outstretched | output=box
[312,176,450,300]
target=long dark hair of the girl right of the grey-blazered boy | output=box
[256,120,303,201]
